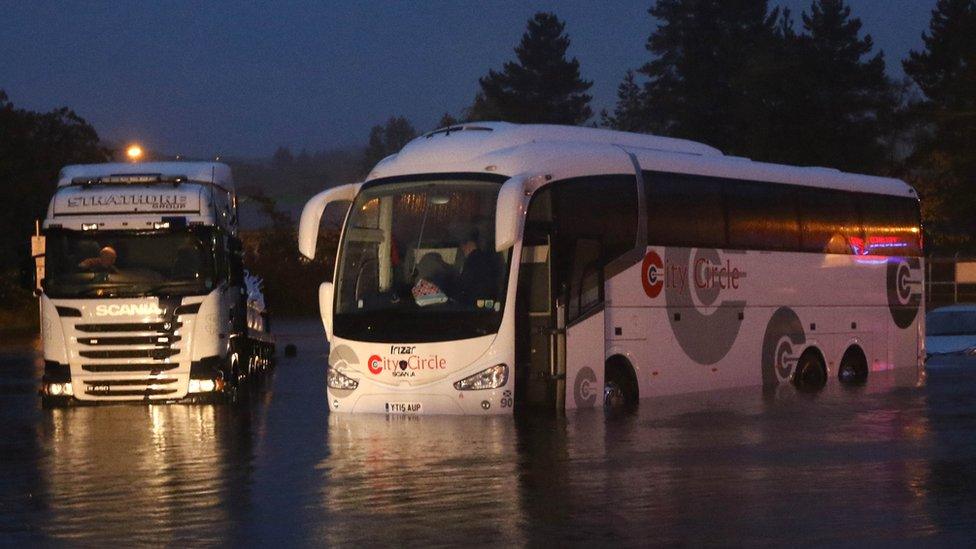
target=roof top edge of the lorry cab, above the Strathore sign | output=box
[58,162,234,191]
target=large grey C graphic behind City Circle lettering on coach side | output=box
[664,248,746,365]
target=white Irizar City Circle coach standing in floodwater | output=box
[299,123,924,414]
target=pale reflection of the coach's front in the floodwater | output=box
[318,414,522,545]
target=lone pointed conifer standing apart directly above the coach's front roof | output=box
[468,13,593,124]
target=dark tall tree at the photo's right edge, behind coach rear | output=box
[903,0,976,248]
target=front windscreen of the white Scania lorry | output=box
[44,229,218,298]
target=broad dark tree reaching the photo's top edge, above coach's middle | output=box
[632,0,779,154]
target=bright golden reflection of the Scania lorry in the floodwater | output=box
[37,406,258,543]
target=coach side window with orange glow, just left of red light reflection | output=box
[797,185,863,255]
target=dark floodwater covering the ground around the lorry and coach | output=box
[0,322,976,546]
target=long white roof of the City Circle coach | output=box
[367,122,915,197]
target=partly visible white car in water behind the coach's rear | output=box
[925,304,976,363]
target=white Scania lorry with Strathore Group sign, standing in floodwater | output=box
[32,162,274,406]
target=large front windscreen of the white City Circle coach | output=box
[334,180,508,342]
